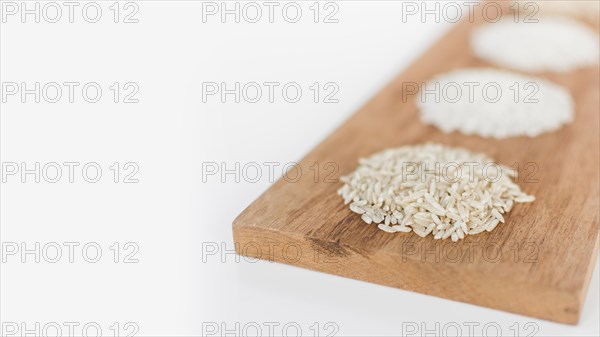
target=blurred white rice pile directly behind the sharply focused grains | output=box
[417,68,574,138]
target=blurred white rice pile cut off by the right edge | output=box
[471,16,600,72]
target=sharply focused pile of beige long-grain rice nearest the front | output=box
[338,144,535,241]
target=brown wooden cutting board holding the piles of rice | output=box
[233,7,600,324]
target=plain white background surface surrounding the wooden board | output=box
[0,1,600,336]
